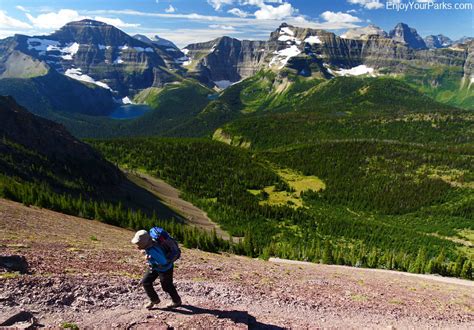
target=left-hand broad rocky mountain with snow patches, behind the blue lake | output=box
[0,19,183,98]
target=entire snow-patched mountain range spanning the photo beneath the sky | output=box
[0,20,474,137]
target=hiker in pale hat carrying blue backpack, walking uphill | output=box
[132,230,181,309]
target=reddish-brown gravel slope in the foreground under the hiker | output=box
[0,199,474,329]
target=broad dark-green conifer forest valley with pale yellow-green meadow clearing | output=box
[91,138,474,278]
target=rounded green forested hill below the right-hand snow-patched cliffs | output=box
[167,71,457,140]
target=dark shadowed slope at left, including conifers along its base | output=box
[0,97,180,225]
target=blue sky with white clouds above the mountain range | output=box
[0,0,474,47]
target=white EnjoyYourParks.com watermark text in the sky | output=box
[385,0,474,11]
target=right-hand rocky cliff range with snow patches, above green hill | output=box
[183,23,473,108]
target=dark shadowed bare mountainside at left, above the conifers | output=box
[0,97,122,189]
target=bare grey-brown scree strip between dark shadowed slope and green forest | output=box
[126,172,229,240]
